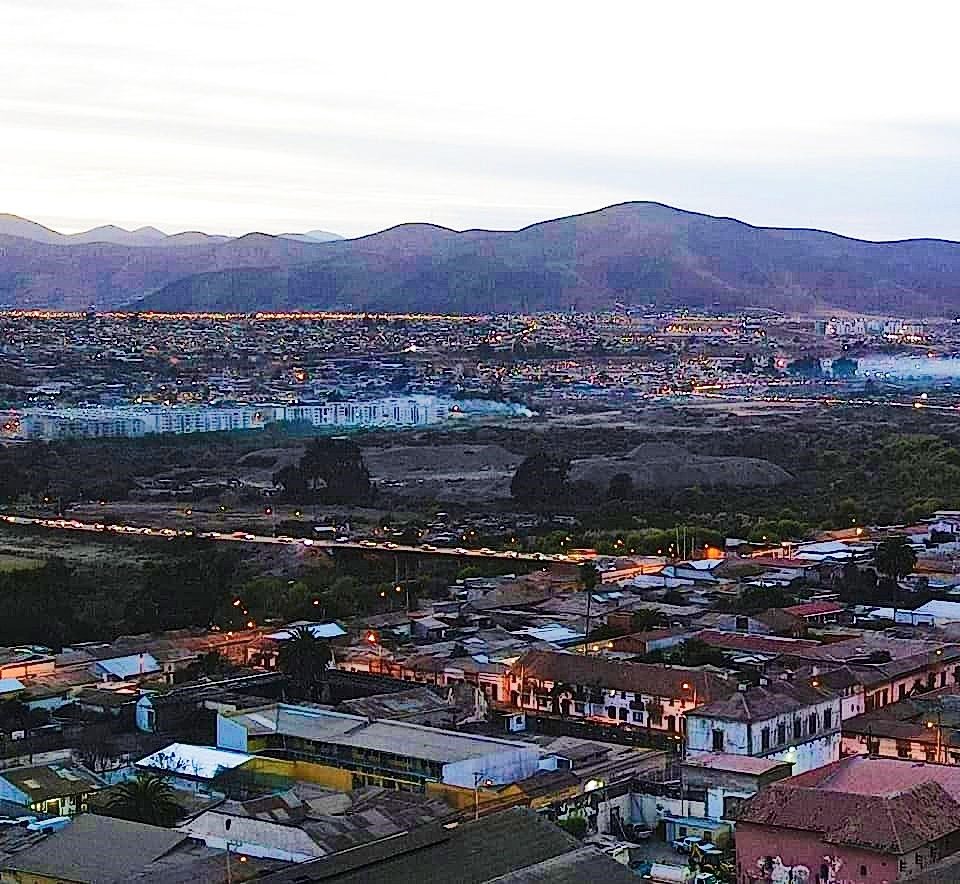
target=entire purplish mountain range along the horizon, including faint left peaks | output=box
[0,202,960,316]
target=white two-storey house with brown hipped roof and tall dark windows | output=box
[686,681,840,773]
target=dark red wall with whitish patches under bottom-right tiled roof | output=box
[737,823,899,884]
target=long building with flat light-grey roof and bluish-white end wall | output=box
[217,703,540,791]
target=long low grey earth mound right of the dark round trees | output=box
[570,442,793,489]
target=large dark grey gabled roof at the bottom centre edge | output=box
[255,808,637,884]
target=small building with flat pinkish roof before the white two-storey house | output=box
[680,752,792,820]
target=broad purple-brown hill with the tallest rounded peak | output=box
[144,203,960,315]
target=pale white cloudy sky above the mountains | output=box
[0,0,960,240]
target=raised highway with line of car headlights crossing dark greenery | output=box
[0,515,580,563]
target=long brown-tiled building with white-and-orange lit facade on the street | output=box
[510,651,736,735]
